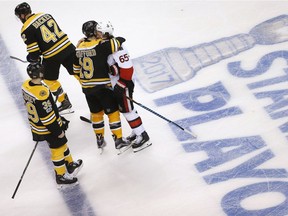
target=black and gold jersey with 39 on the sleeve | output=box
[22,79,62,141]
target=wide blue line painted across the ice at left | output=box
[0,35,96,216]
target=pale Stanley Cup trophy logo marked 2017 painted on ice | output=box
[133,15,288,92]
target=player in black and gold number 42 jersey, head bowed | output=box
[15,2,75,115]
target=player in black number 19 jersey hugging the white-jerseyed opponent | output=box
[74,21,130,152]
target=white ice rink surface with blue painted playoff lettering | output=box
[0,1,288,216]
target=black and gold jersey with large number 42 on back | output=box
[21,13,75,59]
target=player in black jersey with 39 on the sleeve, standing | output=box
[22,62,83,186]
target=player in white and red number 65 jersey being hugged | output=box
[96,21,152,152]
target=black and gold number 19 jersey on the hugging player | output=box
[73,37,125,93]
